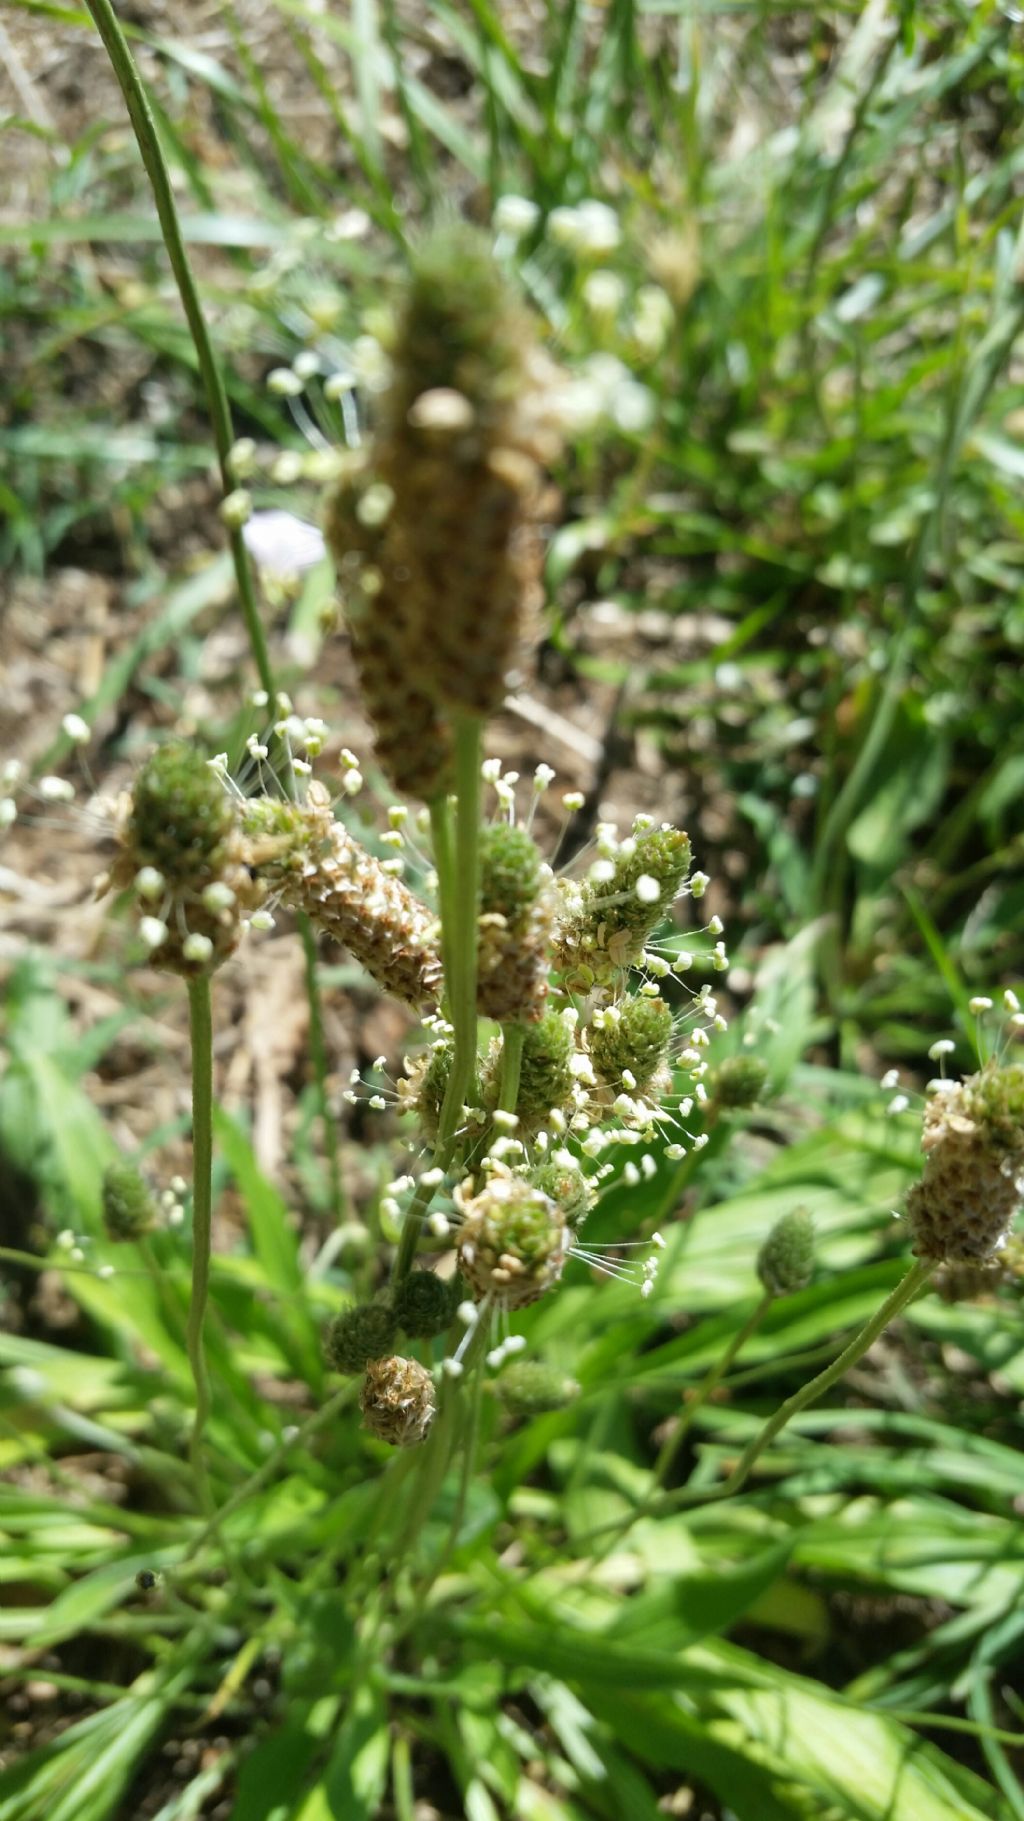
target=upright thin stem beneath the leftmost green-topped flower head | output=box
[186,974,213,1517]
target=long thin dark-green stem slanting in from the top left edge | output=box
[87,0,275,697]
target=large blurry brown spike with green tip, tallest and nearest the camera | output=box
[375,224,552,716]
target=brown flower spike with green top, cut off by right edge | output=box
[906,1062,1024,1264]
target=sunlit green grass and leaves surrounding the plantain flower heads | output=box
[0,0,1024,1821]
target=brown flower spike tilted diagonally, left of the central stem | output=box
[242,783,441,1009]
